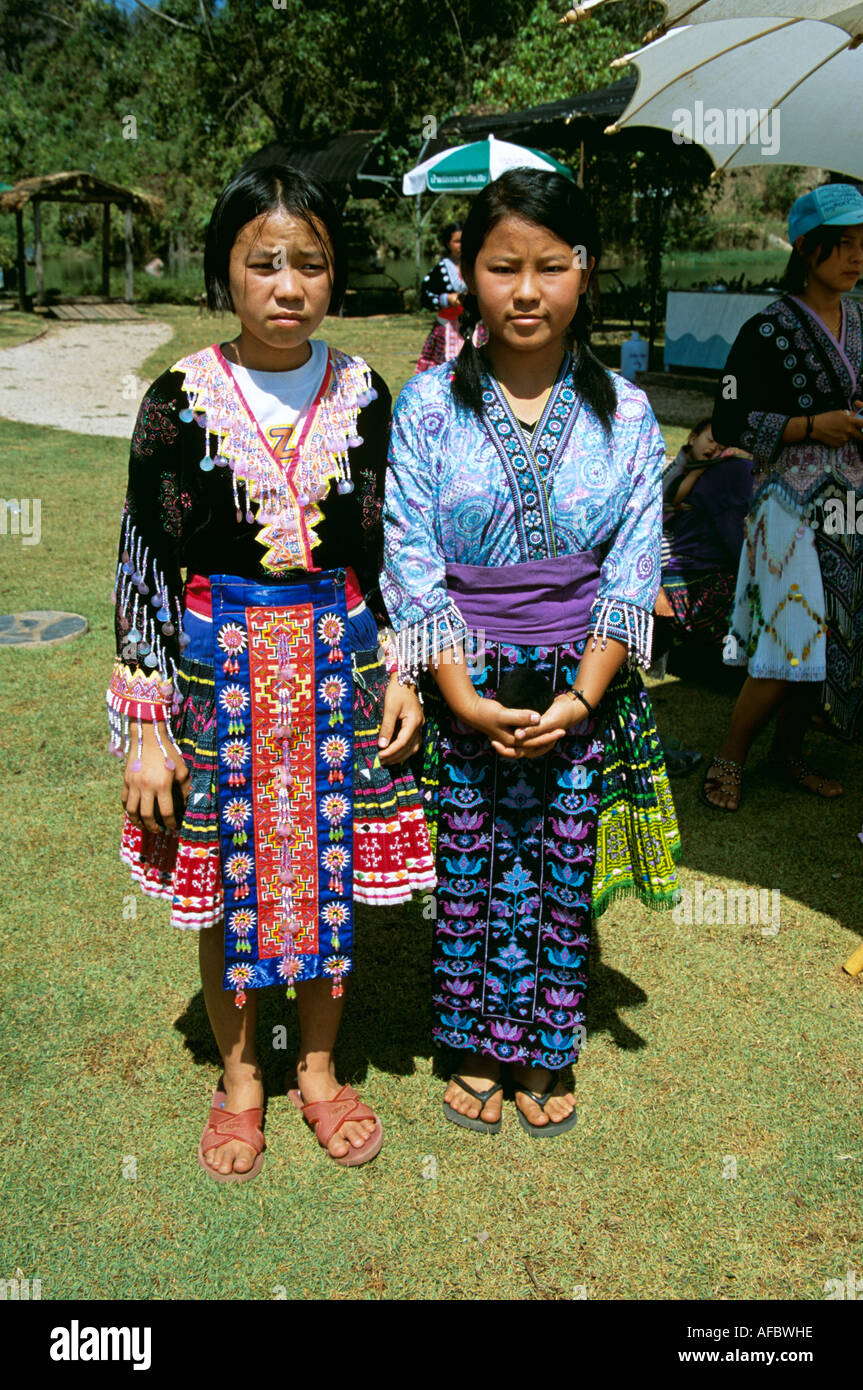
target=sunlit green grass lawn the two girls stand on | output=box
[0,310,863,1300]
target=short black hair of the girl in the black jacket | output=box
[204,164,347,314]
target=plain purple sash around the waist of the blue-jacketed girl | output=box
[446,550,600,646]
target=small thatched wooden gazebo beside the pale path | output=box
[0,170,164,309]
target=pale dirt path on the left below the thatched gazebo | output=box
[0,320,172,439]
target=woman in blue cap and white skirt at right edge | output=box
[702,183,863,810]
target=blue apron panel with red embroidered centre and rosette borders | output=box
[211,571,353,1004]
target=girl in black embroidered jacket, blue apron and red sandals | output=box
[108,165,434,1182]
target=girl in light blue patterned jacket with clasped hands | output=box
[382,170,680,1136]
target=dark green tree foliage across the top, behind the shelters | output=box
[0,0,700,266]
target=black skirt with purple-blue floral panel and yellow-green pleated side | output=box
[425,641,680,1069]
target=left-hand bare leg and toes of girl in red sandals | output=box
[199,927,264,1173]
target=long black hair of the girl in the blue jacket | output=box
[453,168,617,434]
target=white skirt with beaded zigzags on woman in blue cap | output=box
[724,492,827,681]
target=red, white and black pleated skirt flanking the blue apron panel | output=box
[121,600,435,956]
